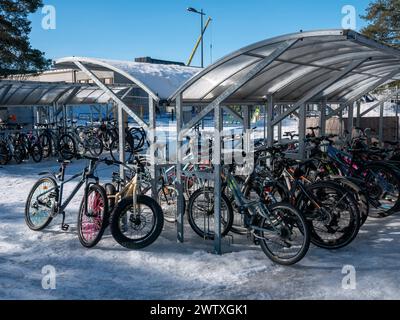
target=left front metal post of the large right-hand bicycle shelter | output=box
[175,94,185,243]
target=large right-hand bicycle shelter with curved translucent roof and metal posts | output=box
[170,30,400,254]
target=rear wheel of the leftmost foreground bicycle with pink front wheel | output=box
[25,178,58,231]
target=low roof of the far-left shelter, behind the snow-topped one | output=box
[0,80,130,106]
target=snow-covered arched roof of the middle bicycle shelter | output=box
[55,57,201,101]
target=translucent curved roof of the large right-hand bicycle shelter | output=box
[170,30,400,103]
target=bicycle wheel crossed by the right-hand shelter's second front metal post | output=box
[188,188,234,240]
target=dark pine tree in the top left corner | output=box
[0,0,51,77]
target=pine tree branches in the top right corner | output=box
[361,0,400,48]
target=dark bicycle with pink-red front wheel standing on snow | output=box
[25,157,109,248]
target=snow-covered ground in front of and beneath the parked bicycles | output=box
[0,162,400,299]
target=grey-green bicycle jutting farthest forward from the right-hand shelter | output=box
[189,166,310,266]
